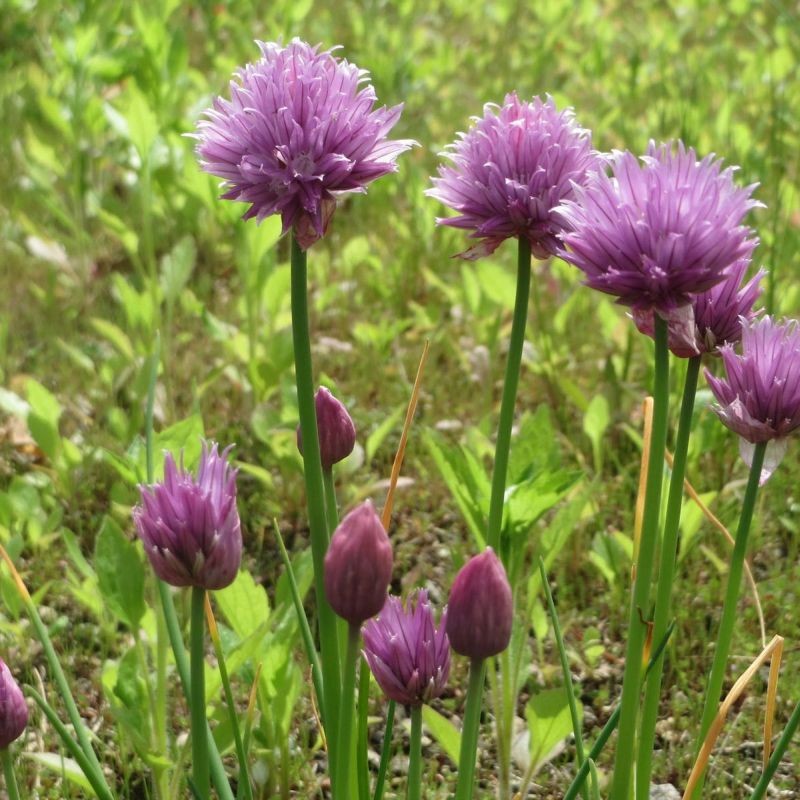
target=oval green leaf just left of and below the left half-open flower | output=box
[94,517,145,629]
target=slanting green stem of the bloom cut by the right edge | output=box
[692,442,767,798]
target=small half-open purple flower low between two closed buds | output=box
[362,589,450,706]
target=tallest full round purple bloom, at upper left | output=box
[196,39,416,249]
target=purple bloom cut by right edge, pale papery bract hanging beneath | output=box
[706,317,800,482]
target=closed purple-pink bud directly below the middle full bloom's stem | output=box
[447,547,514,659]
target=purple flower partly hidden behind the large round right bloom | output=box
[633,258,766,358]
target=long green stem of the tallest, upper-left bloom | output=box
[291,236,341,748]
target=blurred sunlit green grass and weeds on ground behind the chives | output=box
[0,0,800,798]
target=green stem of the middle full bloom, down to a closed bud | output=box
[486,236,531,553]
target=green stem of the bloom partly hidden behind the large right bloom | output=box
[636,355,701,800]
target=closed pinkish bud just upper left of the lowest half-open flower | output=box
[325,500,392,625]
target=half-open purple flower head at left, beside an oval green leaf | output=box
[133,442,242,589]
